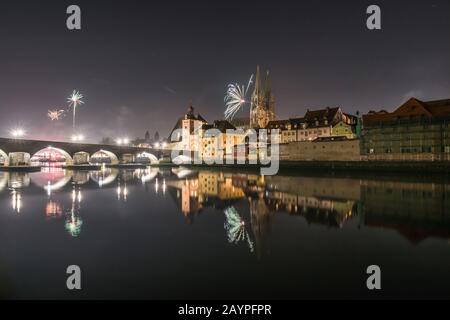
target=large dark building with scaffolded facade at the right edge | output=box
[361,98,450,161]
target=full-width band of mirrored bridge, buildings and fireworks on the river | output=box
[0,167,450,248]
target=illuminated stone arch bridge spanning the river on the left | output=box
[0,138,176,166]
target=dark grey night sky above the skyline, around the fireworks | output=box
[0,0,450,142]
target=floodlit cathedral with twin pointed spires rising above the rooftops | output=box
[250,66,275,128]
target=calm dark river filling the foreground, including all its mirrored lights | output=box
[0,168,450,299]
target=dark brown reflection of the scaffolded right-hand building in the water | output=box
[361,180,450,243]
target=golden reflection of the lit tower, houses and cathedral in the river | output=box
[168,171,360,255]
